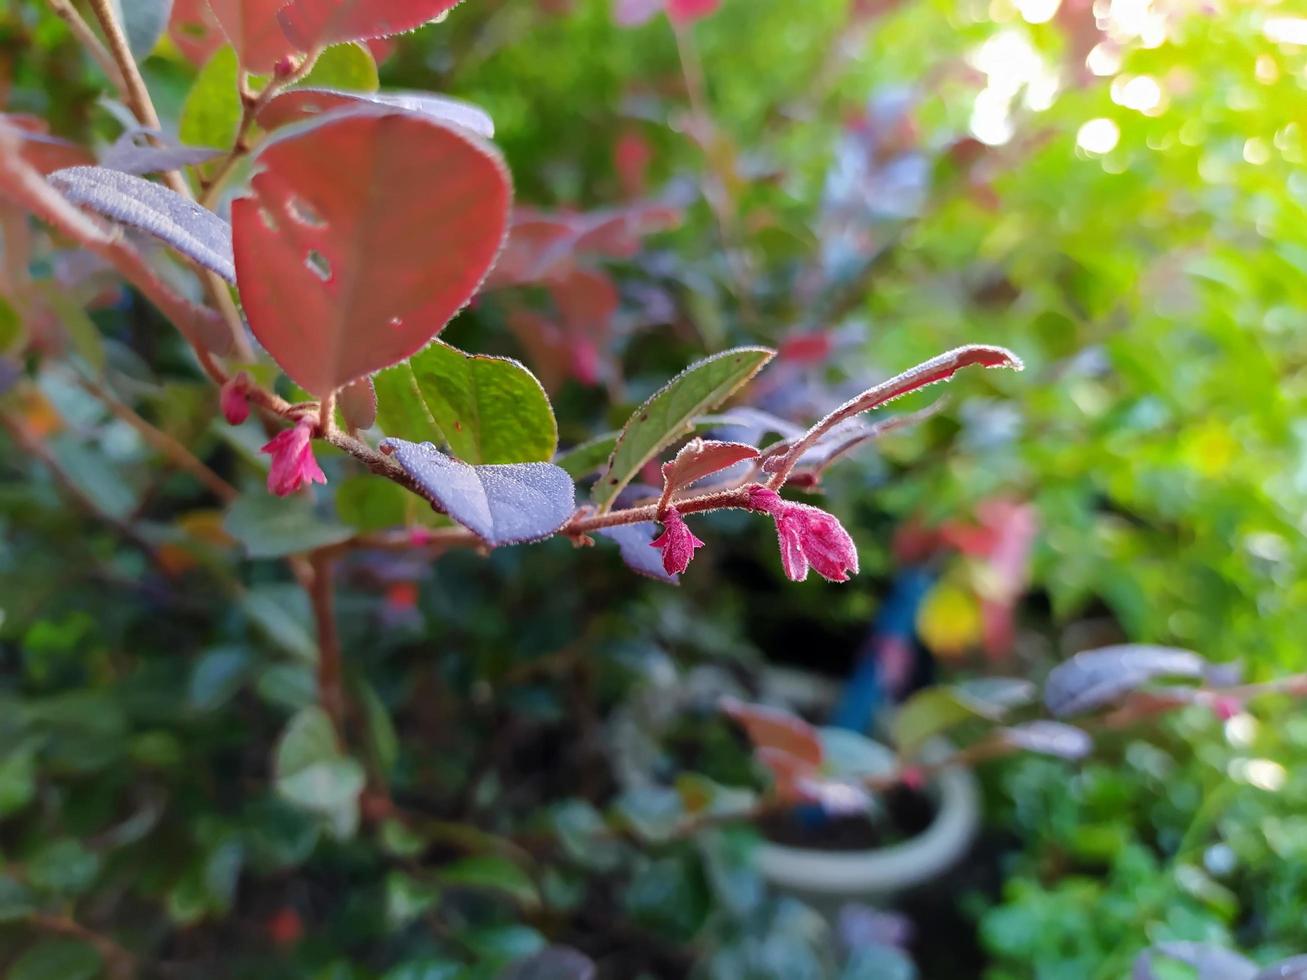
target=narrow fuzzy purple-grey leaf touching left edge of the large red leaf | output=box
[48,167,237,284]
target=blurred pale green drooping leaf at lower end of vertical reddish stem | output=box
[273,704,366,838]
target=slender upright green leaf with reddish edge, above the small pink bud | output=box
[592,348,775,512]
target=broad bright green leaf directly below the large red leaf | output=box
[374,341,558,465]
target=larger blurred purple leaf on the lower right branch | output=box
[1044,643,1206,716]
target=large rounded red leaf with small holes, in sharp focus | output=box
[231,112,511,395]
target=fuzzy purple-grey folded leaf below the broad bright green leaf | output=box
[382,439,572,551]
